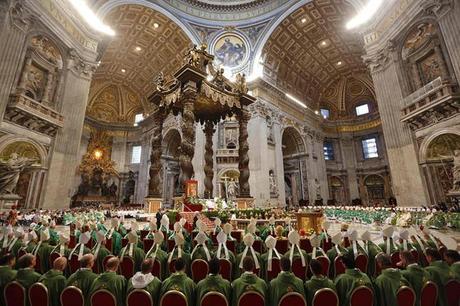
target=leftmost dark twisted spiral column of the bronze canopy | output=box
[148,110,165,198]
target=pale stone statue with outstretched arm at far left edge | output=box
[0,153,38,194]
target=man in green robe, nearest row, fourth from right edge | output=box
[375,254,410,306]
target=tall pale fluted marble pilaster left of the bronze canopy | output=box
[43,54,95,208]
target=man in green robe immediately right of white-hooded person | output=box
[160,258,196,305]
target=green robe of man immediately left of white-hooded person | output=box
[88,271,126,306]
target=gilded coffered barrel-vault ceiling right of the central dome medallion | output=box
[262,0,366,107]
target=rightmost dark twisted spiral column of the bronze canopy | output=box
[238,109,251,198]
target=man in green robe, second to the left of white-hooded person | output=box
[66,254,97,305]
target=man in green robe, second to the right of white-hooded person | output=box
[196,257,232,306]
